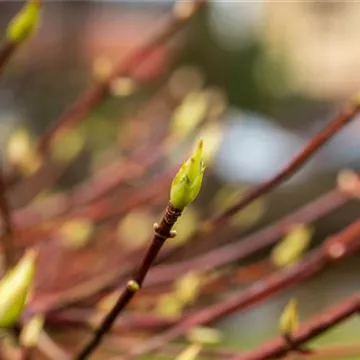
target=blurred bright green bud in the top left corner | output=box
[6,0,40,43]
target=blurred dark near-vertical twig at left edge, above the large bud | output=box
[0,172,15,269]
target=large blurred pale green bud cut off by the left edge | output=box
[0,250,37,328]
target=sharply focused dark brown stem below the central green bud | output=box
[76,204,182,360]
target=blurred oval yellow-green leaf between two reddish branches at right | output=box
[271,224,313,267]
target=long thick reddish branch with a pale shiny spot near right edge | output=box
[132,220,360,355]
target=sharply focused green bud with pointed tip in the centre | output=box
[170,140,205,210]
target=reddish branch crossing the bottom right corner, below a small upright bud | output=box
[229,293,360,360]
